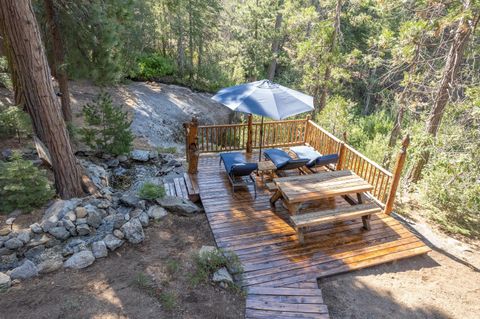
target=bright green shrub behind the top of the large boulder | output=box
[134,53,175,80]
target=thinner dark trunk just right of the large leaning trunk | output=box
[44,0,72,122]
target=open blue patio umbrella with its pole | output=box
[212,80,314,158]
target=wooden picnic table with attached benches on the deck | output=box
[270,170,381,243]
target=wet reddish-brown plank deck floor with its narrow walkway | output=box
[197,154,430,319]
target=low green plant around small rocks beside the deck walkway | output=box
[190,249,243,288]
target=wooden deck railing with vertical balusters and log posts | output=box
[185,116,409,214]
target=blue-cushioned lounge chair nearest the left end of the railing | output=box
[220,152,258,198]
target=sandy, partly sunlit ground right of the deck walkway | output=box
[319,251,480,319]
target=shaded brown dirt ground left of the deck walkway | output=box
[0,214,245,319]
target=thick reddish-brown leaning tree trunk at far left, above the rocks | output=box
[0,0,83,198]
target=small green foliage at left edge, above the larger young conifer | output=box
[0,106,32,139]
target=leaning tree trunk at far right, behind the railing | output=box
[408,5,480,183]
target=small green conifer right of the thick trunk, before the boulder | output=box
[80,93,133,155]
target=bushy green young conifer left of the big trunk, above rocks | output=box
[0,153,55,213]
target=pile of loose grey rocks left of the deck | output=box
[0,151,201,291]
